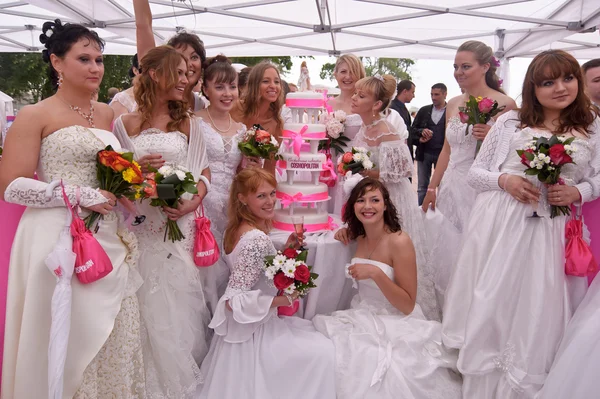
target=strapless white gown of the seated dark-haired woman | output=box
[313,260,461,399]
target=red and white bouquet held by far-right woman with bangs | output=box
[517,135,577,218]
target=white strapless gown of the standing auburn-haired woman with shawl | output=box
[114,118,210,399]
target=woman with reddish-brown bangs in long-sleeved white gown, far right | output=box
[442,50,600,399]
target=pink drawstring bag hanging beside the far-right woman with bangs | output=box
[565,218,598,277]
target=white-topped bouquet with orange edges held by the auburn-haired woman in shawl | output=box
[143,165,198,242]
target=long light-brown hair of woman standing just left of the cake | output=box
[242,61,284,132]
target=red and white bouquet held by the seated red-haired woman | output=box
[264,248,319,297]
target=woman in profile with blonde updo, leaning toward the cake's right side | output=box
[336,75,440,320]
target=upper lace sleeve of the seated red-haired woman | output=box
[225,233,275,296]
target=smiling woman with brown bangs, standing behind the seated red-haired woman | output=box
[196,55,254,302]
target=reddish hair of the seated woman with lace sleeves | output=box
[223,168,277,253]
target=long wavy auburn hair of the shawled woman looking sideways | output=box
[133,46,191,131]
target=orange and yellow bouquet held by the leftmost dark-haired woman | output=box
[85,145,144,229]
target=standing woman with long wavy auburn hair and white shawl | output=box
[114,46,216,399]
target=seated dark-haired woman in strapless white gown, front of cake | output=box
[313,179,461,399]
